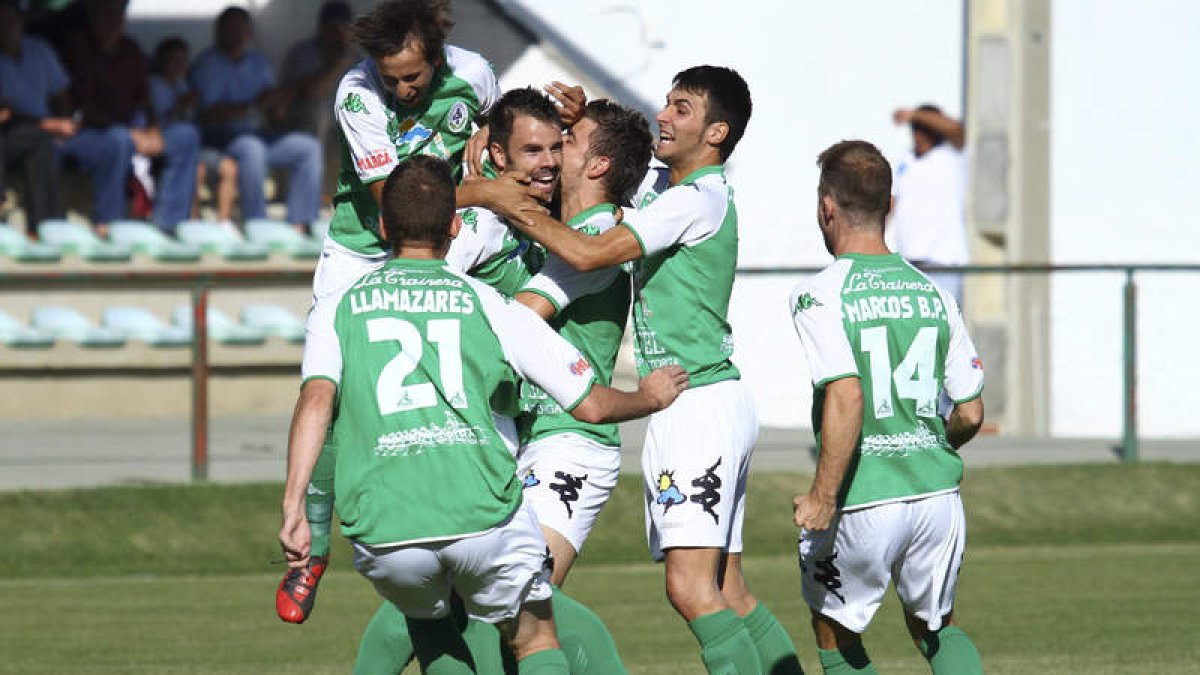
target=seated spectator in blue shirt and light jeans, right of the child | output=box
[190,7,323,231]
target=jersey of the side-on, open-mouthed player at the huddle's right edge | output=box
[622,166,740,387]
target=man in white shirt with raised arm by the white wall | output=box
[888,104,971,306]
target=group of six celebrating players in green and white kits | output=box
[276,5,983,675]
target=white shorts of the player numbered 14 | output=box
[799,490,966,633]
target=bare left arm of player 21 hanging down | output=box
[280,378,337,567]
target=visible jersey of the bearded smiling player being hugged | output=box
[446,207,546,298]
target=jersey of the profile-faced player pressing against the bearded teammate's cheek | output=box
[517,204,629,448]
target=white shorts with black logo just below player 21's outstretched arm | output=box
[517,434,620,552]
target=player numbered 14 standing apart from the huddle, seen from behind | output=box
[790,141,983,675]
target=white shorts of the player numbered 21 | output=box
[350,497,552,623]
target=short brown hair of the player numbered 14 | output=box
[817,141,892,227]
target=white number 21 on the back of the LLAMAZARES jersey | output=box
[366,317,467,414]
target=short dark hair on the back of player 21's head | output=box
[380,155,455,253]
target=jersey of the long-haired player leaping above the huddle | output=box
[329,46,500,256]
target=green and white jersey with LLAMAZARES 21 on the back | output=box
[308,258,595,545]
